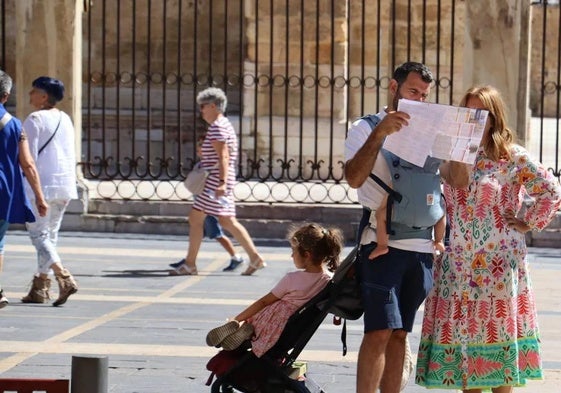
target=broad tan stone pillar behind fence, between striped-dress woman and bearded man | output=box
[243,0,347,178]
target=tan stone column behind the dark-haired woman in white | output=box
[15,0,84,167]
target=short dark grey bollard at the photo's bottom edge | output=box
[70,356,109,393]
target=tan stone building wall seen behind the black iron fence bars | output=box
[4,0,559,182]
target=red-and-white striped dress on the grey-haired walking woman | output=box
[193,116,238,217]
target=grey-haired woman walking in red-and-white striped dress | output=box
[170,87,265,276]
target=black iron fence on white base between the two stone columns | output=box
[80,0,457,203]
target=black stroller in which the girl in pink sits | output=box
[207,247,362,393]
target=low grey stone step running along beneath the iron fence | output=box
[55,200,561,248]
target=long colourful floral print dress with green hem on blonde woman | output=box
[415,145,561,389]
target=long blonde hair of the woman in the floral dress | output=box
[460,85,514,161]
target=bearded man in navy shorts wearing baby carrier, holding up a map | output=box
[345,62,484,393]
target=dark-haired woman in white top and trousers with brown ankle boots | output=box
[22,76,78,306]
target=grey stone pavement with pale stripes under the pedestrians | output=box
[0,231,561,393]
